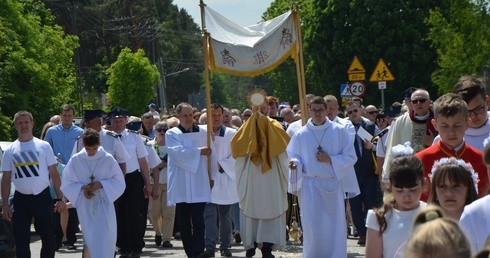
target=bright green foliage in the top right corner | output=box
[426,0,490,94]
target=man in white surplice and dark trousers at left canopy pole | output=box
[165,103,218,257]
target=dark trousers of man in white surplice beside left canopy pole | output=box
[175,202,206,257]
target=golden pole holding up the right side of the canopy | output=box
[292,5,308,125]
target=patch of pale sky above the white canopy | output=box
[173,0,273,26]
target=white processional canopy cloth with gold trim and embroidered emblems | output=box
[204,6,298,76]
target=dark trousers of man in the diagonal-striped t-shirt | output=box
[12,187,55,258]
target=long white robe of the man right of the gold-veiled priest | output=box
[287,119,357,257]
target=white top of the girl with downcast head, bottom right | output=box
[366,201,426,257]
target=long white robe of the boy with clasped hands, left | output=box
[61,147,126,258]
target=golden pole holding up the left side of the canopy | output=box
[199,0,214,188]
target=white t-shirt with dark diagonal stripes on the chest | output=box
[1,137,57,195]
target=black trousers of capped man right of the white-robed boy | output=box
[116,171,146,252]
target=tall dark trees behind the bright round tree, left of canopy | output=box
[45,0,203,106]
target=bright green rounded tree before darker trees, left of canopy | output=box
[107,48,160,116]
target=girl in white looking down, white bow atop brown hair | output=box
[366,144,425,258]
